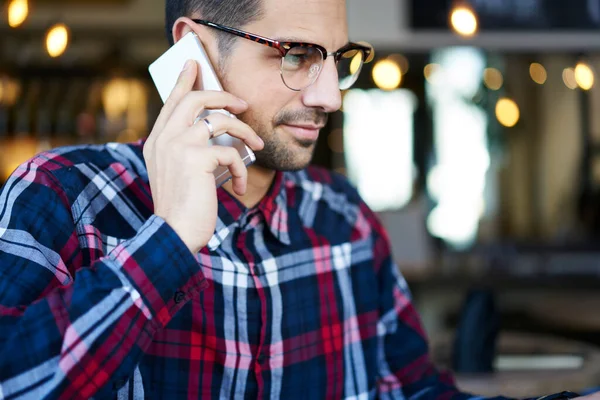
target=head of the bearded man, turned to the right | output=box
[166,0,348,170]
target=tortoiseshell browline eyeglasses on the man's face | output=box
[192,19,374,91]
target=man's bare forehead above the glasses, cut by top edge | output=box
[247,0,348,50]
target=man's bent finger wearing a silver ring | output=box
[190,113,264,150]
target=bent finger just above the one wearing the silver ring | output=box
[167,91,248,132]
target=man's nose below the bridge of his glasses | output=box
[302,57,342,113]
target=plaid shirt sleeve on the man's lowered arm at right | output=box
[363,206,510,400]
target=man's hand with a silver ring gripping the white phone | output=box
[144,36,263,253]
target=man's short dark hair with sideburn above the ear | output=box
[165,0,262,58]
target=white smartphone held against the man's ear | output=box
[148,32,256,187]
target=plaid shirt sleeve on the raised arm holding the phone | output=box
[0,163,207,399]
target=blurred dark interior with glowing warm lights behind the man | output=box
[0,0,600,396]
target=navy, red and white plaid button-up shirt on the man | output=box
[0,141,486,400]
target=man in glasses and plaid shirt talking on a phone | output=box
[0,0,596,399]
